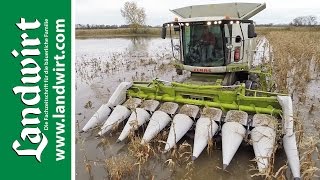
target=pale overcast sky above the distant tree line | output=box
[76,0,320,26]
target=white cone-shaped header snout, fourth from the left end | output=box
[141,102,179,144]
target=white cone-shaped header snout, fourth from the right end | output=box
[192,108,222,160]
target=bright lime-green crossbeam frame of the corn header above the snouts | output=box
[128,80,281,115]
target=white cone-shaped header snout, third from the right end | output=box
[221,110,248,170]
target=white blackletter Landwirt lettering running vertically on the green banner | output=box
[11,18,48,162]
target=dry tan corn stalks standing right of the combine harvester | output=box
[258,27,320,179]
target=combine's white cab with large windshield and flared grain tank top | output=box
[162,3,266,85]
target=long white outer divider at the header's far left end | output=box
[81,82,132,132]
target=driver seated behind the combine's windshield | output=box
[201,26,215,63]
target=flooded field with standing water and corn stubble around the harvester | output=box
[75,35,320,180]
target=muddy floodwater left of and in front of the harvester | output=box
[75,38,312,180]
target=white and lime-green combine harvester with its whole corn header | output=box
[82,3,300,179]
